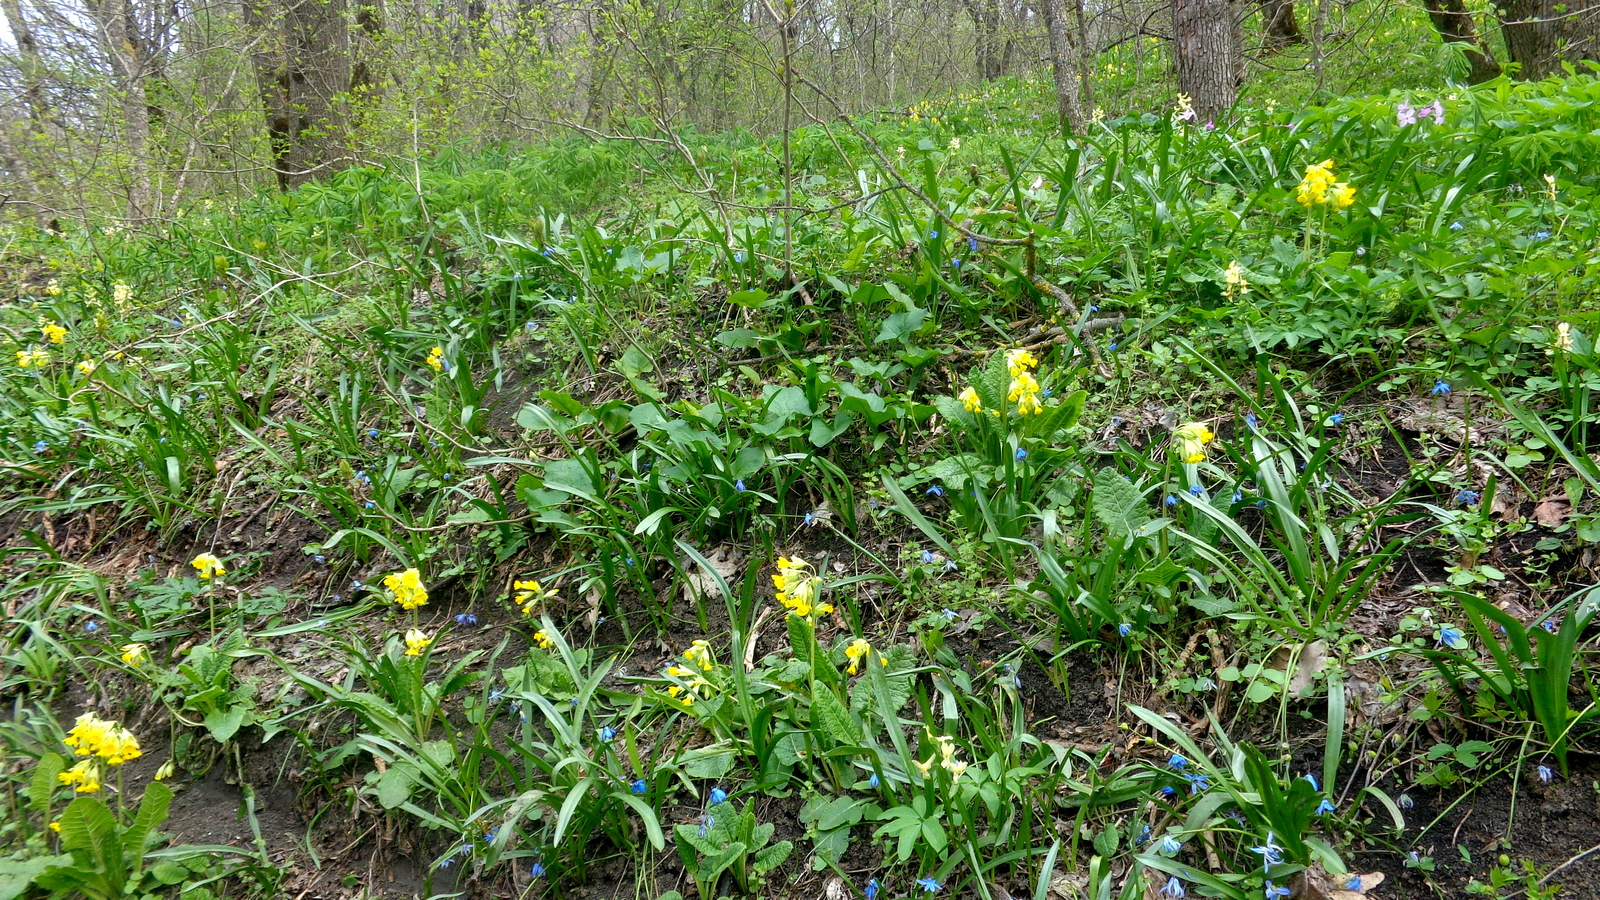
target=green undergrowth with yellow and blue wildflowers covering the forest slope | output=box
[0,68,1600,900]
